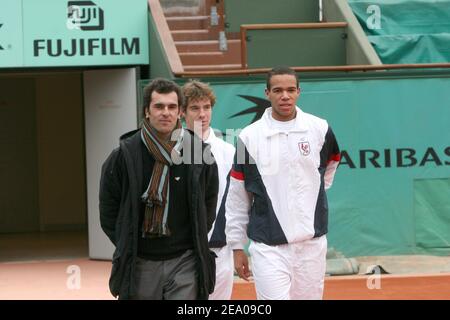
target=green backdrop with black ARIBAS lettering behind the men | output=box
[203,73,450,256]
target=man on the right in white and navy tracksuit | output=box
[226,67,340,300]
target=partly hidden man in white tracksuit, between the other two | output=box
[182,80,235,300]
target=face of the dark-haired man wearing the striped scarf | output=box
[145,91,180,139]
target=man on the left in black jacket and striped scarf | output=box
[100,79,218,299]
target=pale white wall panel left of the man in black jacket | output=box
[83,68,137,259]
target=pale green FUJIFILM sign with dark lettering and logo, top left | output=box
[20,0,148,66]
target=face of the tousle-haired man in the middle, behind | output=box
[183,98,212,136]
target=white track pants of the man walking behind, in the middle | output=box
[209,246,234,300]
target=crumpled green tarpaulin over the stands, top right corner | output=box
[348,0,450,64]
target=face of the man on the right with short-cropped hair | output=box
[266,74,300,121]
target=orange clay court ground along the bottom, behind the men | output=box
[0,259,450,300]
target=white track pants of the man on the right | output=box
[249,236,327,300]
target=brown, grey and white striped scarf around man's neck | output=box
[141,119,184,238]
